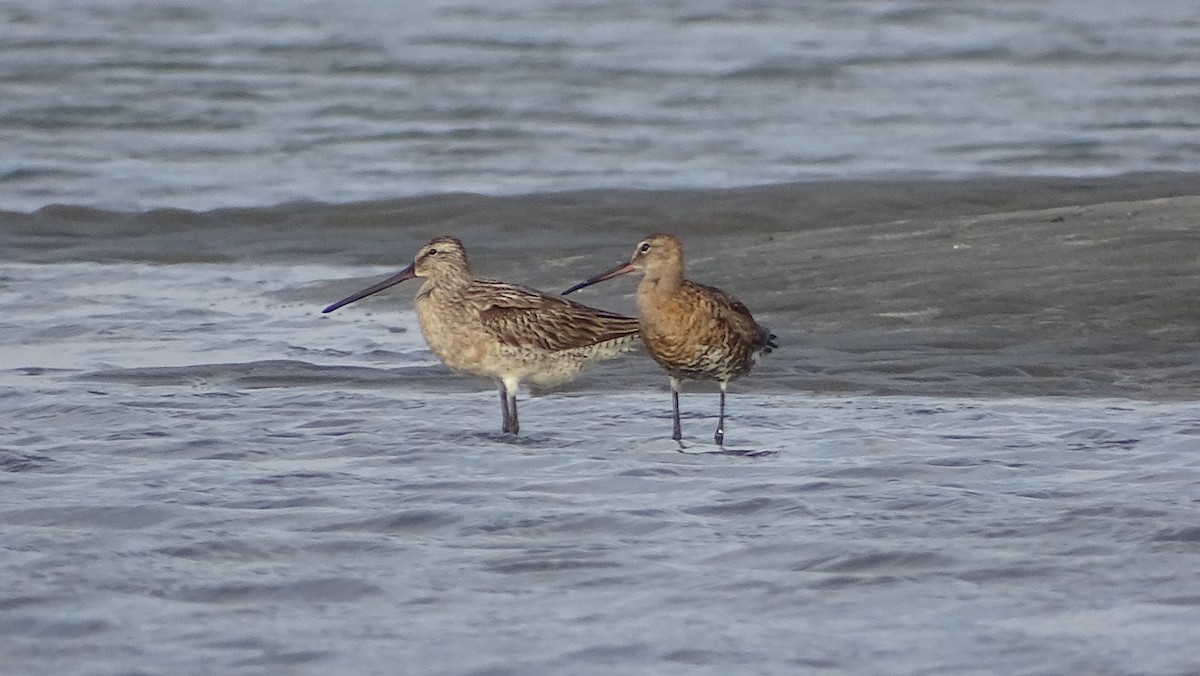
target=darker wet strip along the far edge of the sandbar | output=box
[0,173,1200,267]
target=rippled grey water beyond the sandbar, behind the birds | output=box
[0,0,1200,210]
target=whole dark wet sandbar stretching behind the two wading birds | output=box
[0,174,1200,399]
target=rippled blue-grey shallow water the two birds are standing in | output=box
[7,263,1200,675]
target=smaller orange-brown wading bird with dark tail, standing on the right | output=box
[563,234,778,448]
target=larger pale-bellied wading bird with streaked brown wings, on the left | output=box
[322,237,637,435]
